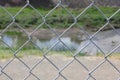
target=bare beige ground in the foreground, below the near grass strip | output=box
[0,55,120,80]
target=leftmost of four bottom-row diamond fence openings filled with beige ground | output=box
[2,59,29,80]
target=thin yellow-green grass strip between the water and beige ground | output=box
[0,49,120,60]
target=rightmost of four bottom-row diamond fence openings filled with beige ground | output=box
[92,62,120,80]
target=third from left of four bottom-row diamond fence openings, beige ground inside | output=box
[61,59,88,80]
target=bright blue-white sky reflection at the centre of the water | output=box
[36,37,79,51]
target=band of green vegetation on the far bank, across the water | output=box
[0,7,120,29]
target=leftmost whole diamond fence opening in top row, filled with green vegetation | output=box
[15,6,43,31]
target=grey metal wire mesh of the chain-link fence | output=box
[0,0,120,80]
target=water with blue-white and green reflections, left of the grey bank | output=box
[1,35,79,51]
